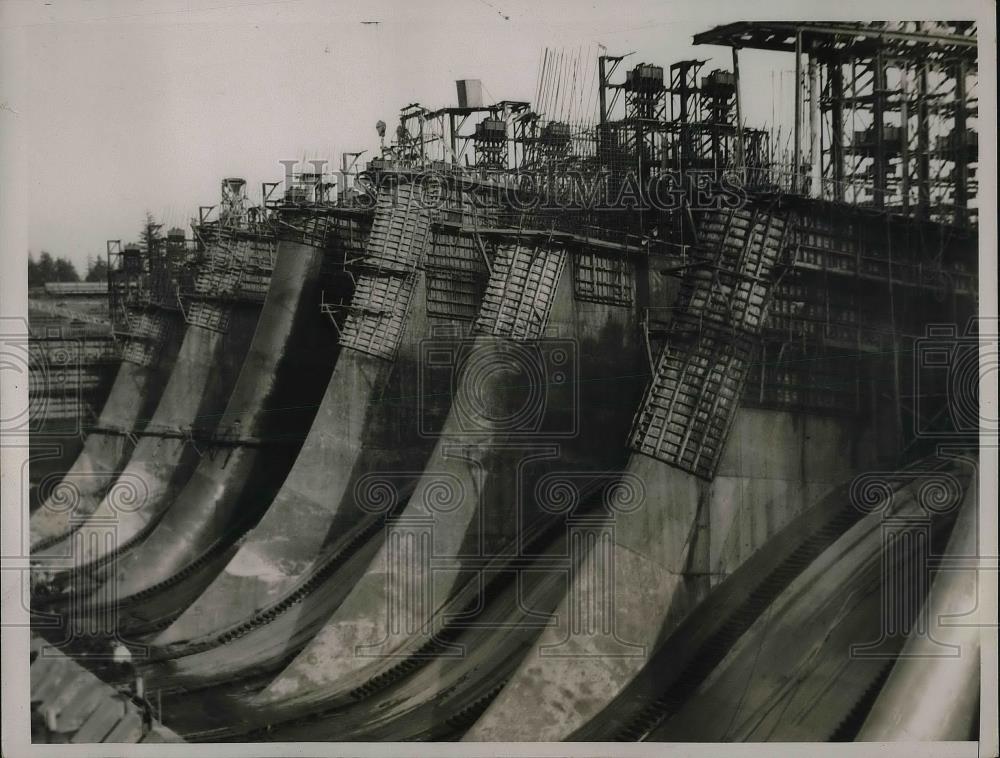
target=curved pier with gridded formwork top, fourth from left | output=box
[149,185,432,645]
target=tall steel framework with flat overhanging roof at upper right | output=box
[694,21,978,226]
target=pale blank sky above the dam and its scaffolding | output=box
[0,0,976,273]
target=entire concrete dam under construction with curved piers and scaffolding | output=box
[30,22,995,743]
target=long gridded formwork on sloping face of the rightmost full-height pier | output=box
[630,209,785,479]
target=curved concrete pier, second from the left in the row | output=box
[33,229,273,594]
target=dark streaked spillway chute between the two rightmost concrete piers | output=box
[571,452,971,741]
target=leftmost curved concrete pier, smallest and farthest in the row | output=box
[30,310,184,551]
